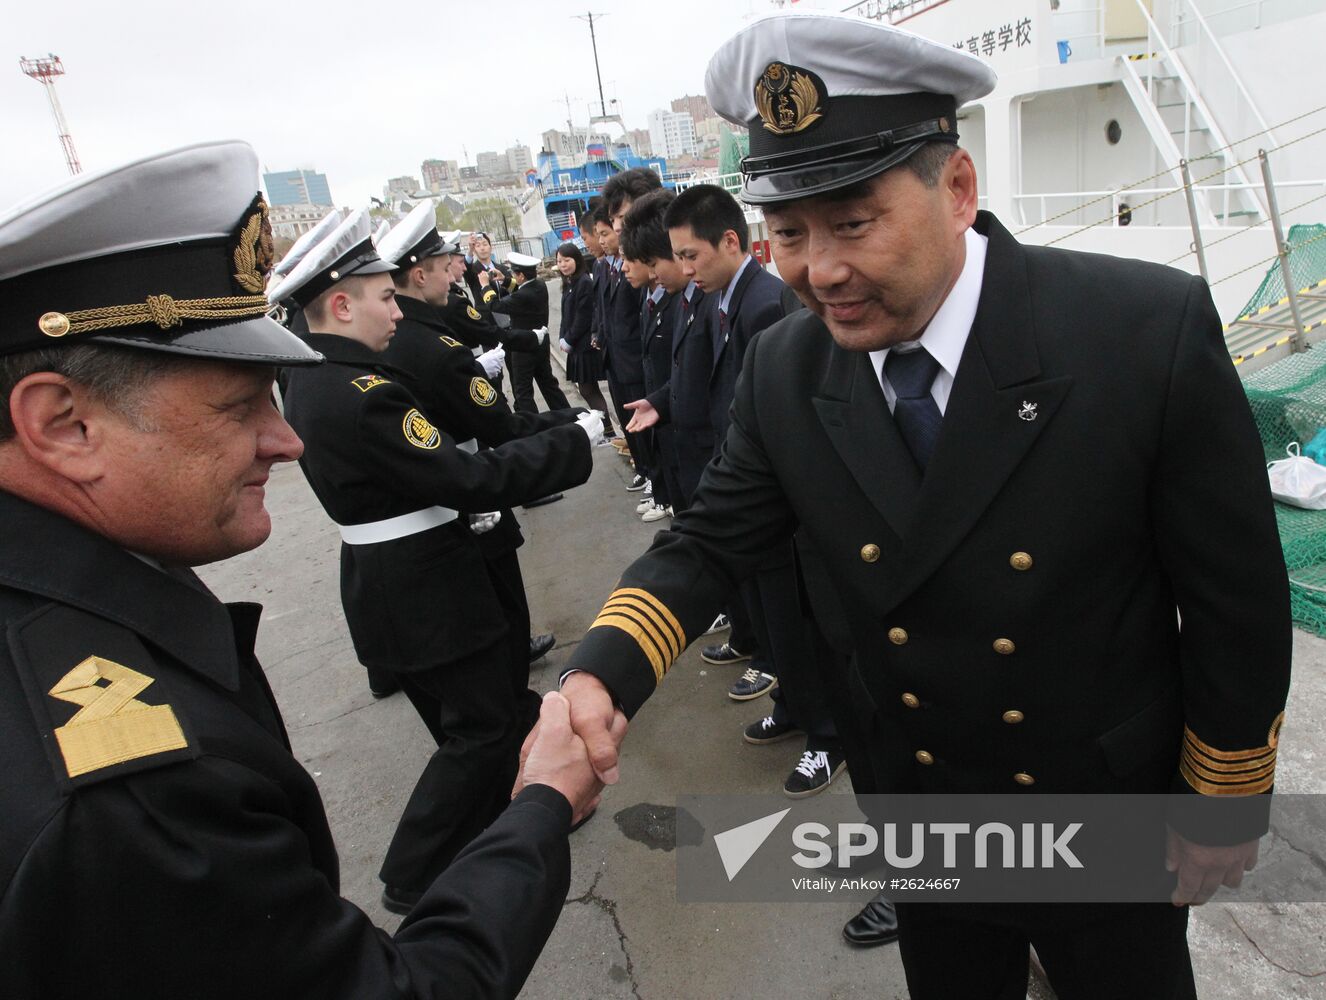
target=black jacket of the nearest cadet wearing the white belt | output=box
[285,333,593,671]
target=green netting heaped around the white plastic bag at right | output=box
[1244,347,1326,635]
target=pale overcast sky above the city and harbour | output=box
[0,0,843,211]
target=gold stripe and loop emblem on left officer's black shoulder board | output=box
[49,656,188,779]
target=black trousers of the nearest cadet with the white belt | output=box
[379,552,540,891]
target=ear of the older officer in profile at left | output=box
[9,371,115,483]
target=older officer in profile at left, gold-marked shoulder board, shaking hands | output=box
[0,142,597,1000]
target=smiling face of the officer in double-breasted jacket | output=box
[763,150,976,351]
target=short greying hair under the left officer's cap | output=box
[0,344,180,442]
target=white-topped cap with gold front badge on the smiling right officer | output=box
[704,13,997,203]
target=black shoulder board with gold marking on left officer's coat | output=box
[11,605,200,788]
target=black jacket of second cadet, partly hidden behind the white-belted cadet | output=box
[381,296,585,556]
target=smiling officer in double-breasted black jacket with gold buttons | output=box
[533,15,1292,1000]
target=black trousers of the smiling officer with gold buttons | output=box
[898,903,1197,1000]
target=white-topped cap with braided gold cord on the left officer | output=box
[0,141,321,365]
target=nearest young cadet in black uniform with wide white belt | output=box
[271,210,602,912]
